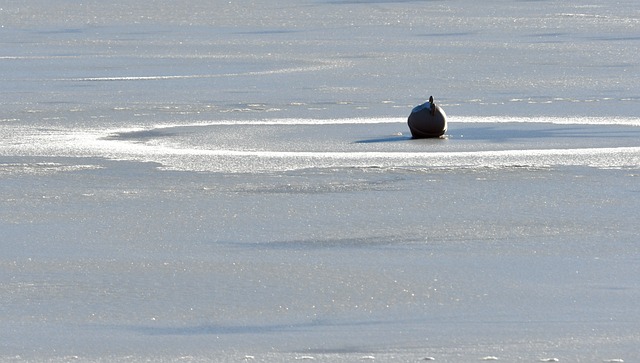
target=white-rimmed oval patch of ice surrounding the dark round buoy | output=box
[1,117,640,173]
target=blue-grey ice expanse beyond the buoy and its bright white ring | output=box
[0,0,640,123]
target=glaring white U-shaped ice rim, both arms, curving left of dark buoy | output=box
[7,118,640,173]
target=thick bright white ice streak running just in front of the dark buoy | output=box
[76,132,640,173]
